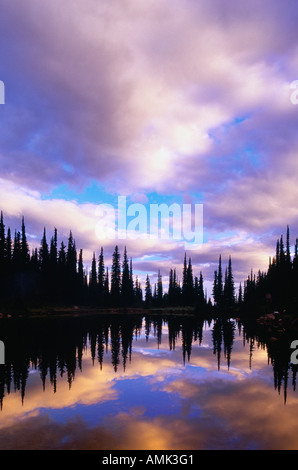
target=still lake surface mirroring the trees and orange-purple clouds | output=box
[0,315,298,450]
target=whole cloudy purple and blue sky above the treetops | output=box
[0,0,298,294]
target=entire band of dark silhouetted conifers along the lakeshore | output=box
[0,212,298,316]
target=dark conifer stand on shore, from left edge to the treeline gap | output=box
[0,212,207,308]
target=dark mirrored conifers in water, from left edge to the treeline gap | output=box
[0,315,204,407]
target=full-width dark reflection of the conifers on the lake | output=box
[0,314,297,408]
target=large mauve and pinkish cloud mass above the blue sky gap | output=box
[2,0,295,195]
